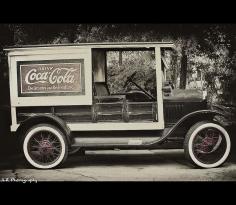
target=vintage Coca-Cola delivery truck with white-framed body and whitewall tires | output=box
[5,42,231,169]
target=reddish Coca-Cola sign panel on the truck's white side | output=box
[20,62,83,94]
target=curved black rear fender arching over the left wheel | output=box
[16,114,71,146]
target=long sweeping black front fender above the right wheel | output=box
[162,110,230,139]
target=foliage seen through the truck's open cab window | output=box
[107,51,156,95]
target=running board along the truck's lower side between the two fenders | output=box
[72,137,160,147]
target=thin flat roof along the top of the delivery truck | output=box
[4,42,174,51]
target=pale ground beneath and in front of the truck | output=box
[0,150,236,182]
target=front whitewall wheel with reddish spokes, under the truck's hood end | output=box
[184,122,231,168]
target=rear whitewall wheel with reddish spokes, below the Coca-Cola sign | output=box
[23,124,68,169]
